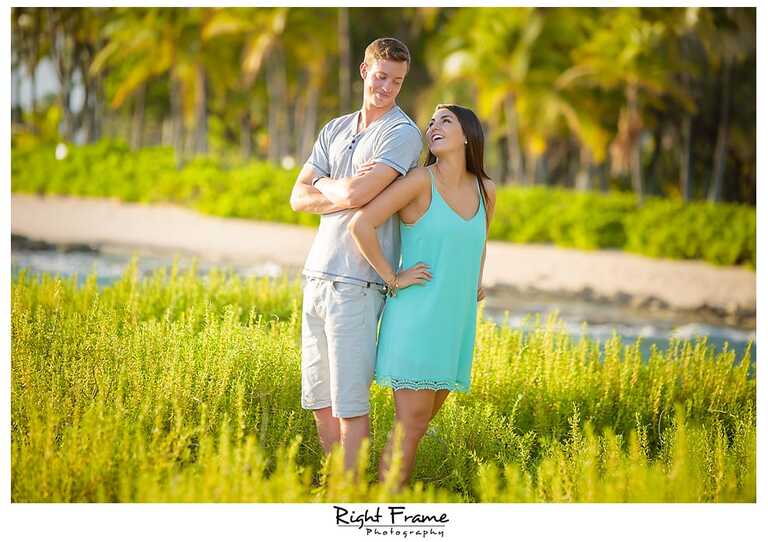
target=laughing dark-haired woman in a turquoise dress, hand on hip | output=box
[349,105,496,485]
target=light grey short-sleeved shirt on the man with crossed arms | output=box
[303,105,422,285]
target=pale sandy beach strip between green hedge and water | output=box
[11,194,756,326]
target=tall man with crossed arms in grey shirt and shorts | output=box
[291,38,422,469]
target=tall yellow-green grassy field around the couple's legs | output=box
[11,262,756,502]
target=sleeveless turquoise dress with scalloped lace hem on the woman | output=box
[374,167,486,391]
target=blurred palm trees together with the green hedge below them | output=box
[12,7,756,267]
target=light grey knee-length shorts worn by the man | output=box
[301,277,384,418]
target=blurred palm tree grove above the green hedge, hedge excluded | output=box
[12,7,756,204]
